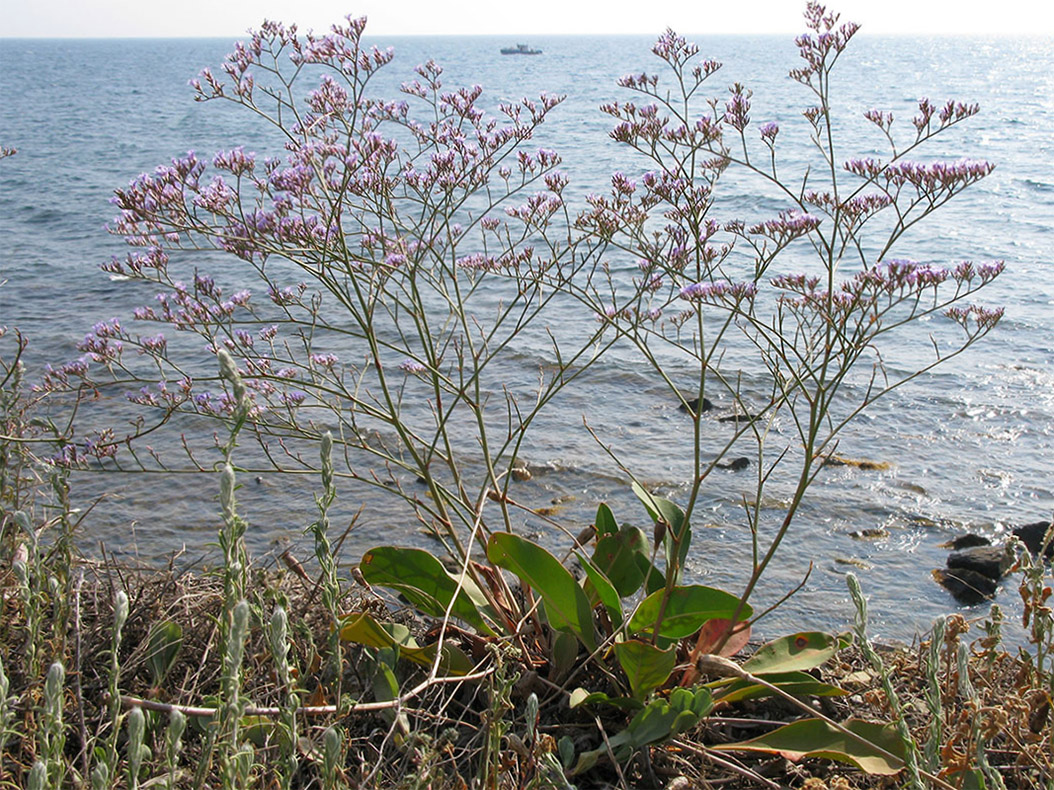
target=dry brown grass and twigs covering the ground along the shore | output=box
[0,547,1054,790]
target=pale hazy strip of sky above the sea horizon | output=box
[0,0,1054,37]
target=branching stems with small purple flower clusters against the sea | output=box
[42,3,1002,615]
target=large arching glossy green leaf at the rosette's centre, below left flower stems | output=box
[487,532,597,653]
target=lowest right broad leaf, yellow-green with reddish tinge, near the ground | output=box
[710,718,904,776]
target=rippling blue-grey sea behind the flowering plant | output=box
[0,31,1054,641]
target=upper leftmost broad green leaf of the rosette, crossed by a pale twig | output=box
[358,546,494,635]
